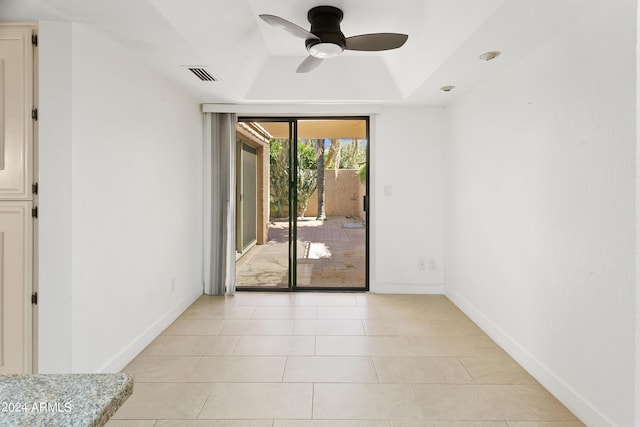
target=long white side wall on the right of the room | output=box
[446,1,636,426]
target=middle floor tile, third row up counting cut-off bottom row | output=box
[284,356,378,383]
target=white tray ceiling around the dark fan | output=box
[0,0,606,105]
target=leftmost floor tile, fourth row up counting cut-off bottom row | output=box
[141,335,238,356]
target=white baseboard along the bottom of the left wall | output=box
[98,289,202,373]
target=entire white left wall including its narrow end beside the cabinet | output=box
[39,23,202,372]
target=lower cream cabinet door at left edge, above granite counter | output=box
[0,202,33,374]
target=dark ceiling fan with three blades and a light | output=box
[259,6,409,73]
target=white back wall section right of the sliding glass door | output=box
[370,107,447,293]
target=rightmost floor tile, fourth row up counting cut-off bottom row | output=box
[393,334,507,357]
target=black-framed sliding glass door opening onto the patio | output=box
[236,118,369,290]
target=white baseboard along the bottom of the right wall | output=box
[445,289,615,427]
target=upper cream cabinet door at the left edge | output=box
[0,26,33,200]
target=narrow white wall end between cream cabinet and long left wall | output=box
[37,22,72,372]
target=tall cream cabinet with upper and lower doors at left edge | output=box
[0,24,36,374]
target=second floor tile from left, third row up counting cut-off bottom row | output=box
[186,356,286,382]
